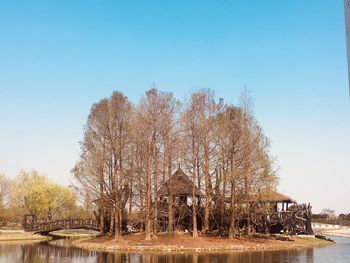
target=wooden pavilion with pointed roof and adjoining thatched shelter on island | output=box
[157,168,313,235]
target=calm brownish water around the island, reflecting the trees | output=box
[0,238,350,263]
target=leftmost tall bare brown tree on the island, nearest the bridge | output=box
[73,92,133,238]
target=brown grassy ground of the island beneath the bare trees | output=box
[74,234,332,252]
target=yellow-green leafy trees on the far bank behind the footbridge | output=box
[0,170,91,227]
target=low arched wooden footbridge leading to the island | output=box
[22,215,100,235]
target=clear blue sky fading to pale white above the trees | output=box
[0,0,350,213]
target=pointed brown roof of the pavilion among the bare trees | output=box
[157,168,202,196]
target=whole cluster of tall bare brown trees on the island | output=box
[72,88,277,239]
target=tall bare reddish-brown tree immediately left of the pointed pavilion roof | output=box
[137,88,177,239]
